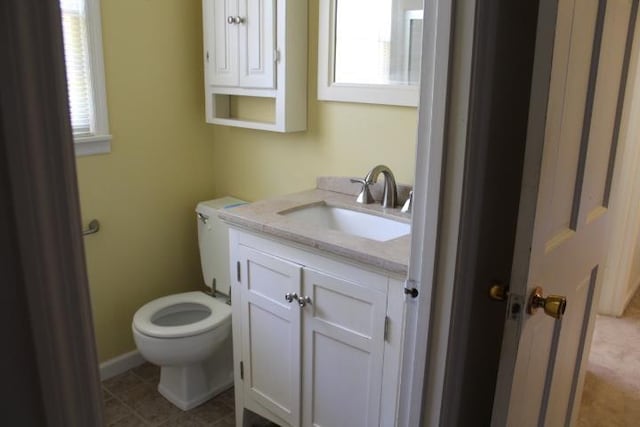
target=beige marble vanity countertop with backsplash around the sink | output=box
[219,178,411,275]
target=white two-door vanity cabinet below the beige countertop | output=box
[230,229,403,427]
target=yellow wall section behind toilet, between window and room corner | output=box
[77,0,215,361]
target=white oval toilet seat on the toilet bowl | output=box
[133,292,231,338]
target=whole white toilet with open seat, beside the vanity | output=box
[131,197,245,411]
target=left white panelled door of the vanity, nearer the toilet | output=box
[234,245,302,426]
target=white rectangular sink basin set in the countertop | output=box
[280,205,411,242]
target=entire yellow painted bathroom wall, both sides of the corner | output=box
[78,0,417,361]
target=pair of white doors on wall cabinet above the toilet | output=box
[204,0,276,89]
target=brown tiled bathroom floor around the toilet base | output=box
[102,363,275,427]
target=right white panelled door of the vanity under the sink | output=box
[302,268,387,427]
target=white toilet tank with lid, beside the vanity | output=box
[196,197,246,295]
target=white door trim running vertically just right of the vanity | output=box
[397,0,476,426]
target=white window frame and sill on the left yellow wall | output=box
[62,0,111,156]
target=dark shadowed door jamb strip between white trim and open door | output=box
[440,0,538,426]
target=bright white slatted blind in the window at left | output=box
[60,0,95,136]
